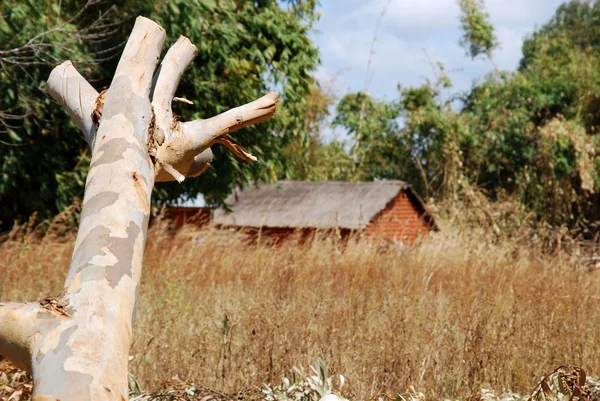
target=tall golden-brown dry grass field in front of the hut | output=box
[0,208,600,399]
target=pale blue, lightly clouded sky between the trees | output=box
[312,0,564,103]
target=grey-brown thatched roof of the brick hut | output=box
[213,181,435,230]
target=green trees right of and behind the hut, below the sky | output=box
[326,1,600,230]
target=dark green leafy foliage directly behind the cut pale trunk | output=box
[0,0,318,224]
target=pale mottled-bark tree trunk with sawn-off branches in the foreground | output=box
[0,17,277,401]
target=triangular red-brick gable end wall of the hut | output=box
[367,192,429,244]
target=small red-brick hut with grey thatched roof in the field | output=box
[207,181,437,243]
